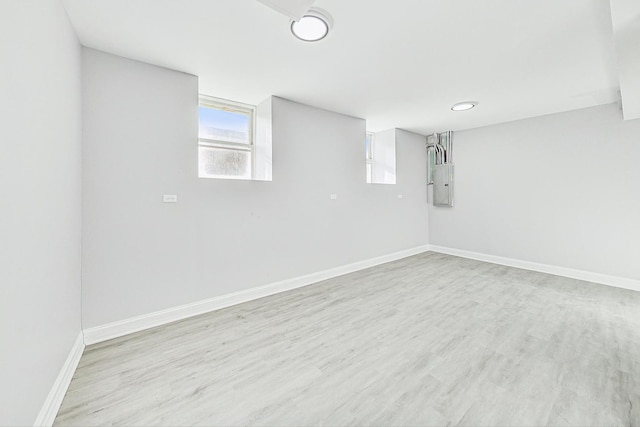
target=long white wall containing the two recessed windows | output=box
[83,49,427,327]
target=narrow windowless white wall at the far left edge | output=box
[0,0,81,426]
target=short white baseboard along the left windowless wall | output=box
[33,333,84,427]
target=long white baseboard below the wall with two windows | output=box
[83,245,429,345]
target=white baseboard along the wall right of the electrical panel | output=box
[430,245,640,292]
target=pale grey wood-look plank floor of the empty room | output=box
[55,253,640,426]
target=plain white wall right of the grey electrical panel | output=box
[429,105,640,279]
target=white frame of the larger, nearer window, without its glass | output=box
[198,94,256,181]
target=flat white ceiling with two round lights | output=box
[64,0,618,134]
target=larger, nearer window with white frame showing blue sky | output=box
[198,95,256,179]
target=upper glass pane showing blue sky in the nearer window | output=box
[198,106,251,144]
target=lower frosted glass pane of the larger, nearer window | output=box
[198,146,251,179]
